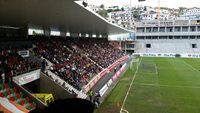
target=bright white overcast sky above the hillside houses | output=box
[87,0,200,8]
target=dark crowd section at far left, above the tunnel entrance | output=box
[0,49,40,80]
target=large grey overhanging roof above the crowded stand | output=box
[0,0,133,34]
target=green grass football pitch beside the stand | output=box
[95,57,200,113]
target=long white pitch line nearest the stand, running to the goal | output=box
[120,58,142,113]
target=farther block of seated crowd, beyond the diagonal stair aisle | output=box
[77,38,125,68]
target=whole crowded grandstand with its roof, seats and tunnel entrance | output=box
[0,0,130,113]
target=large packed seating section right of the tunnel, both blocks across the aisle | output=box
[34,38,125,90]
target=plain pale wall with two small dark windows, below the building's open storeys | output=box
[136,39,200,53]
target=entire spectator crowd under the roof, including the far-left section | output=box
[0,37,125,90]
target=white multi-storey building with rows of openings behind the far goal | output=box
[135,20,200,54]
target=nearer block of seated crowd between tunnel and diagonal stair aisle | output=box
[34,38,102,90]
